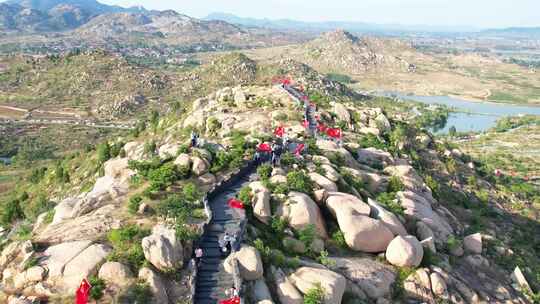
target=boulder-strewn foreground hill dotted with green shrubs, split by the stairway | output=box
[0,67,540,304]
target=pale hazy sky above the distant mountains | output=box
[98,0,540,28]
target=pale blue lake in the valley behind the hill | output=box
[385,93,540,133]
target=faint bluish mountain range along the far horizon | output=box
[204,13,479,34]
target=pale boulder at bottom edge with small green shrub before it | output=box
[289,267,347,304]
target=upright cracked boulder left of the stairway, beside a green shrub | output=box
[142,224,184,271]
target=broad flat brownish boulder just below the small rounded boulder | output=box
[330,257,396,300]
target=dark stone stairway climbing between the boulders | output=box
[194,168,257,304]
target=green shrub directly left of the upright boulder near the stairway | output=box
[107,225,150,272]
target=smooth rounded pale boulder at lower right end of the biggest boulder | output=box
[386,235,424,267]
